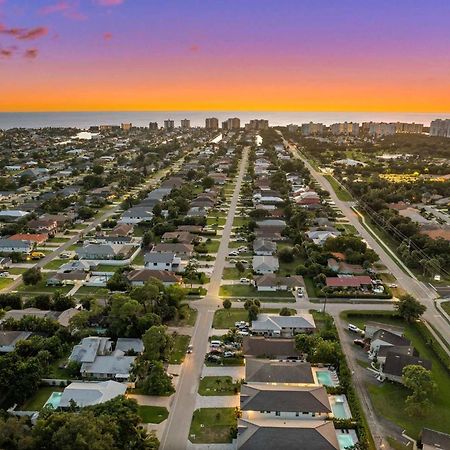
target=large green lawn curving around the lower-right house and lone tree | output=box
[344,314,450,438]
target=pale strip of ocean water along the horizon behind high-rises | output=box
[0,111,450,130]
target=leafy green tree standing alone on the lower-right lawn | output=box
[402,365,436,416]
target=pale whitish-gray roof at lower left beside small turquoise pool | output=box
[59,380,127,408]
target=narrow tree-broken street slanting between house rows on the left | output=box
[0,151,196,292]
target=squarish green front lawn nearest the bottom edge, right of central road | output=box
[189,408,237,444]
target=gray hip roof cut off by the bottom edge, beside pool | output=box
[238,419,339,450]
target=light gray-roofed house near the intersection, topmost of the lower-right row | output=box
[250,313,316,338]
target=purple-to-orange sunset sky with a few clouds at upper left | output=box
[0,0,450,112]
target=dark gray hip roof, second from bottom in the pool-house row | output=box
[241,384,331,413]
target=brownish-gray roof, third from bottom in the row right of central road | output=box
[245,358,314,383]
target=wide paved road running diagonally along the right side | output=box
[284,137,450,348]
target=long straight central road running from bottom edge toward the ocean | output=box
[161,148,248,450]
